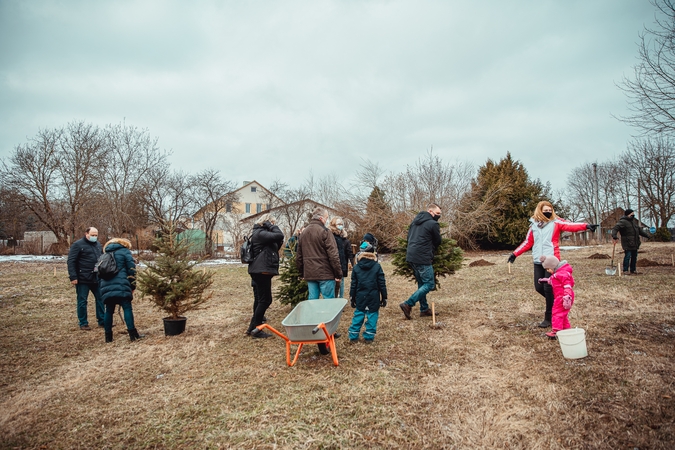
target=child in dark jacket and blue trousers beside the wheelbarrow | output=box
[349,242,387,344]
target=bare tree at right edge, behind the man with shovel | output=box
[624,136,675,228]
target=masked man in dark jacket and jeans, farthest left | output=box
[68,227,103,331]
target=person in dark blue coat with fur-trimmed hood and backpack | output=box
[98,238,145,342]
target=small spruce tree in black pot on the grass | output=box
[136,227,213,336]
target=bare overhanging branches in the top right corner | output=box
[619,0,675,133]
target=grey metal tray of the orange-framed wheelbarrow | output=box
[281,298,347,342]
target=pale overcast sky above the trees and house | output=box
[0,0,654,193]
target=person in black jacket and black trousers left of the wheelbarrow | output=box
[246,214,284,338]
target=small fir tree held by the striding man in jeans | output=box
[392,222,464,289]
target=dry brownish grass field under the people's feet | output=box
[0,243,675,449]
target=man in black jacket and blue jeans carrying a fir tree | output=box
[399,203,442,320]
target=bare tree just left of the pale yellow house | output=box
[190,169,238,255]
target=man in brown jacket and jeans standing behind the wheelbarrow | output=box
[295,207,342,300]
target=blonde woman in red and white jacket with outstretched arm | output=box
[509,201,598,328]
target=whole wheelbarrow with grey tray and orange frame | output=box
[258,298,347,367]
